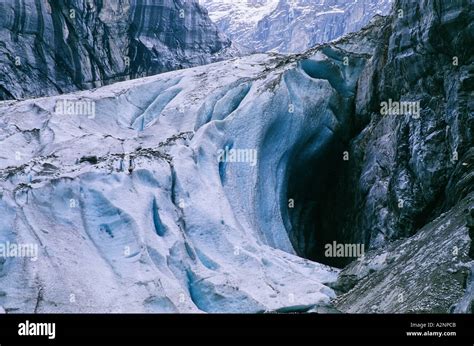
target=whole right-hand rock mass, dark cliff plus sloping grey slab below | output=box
[318,0,474,313]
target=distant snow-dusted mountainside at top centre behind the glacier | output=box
[202,0,393,53]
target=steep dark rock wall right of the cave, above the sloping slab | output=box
[315,1,474,264]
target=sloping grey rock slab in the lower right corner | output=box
[335,194,474,313]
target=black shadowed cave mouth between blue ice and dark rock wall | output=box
[286,138,365,268]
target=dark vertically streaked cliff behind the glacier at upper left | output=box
[0,0,232,100]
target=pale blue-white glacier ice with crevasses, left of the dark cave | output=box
[0,42,364,312]
